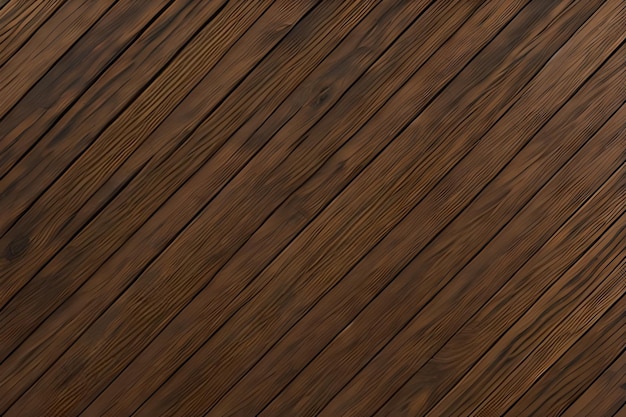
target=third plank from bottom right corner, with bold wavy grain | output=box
[466,260,626,416]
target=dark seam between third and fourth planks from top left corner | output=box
[0,0,175,182]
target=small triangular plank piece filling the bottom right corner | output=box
[563,350,626,417]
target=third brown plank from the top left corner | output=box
[0,0,193,177]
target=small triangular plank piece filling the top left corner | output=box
[0,0,63,67]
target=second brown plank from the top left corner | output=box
[0,0,115,119]
